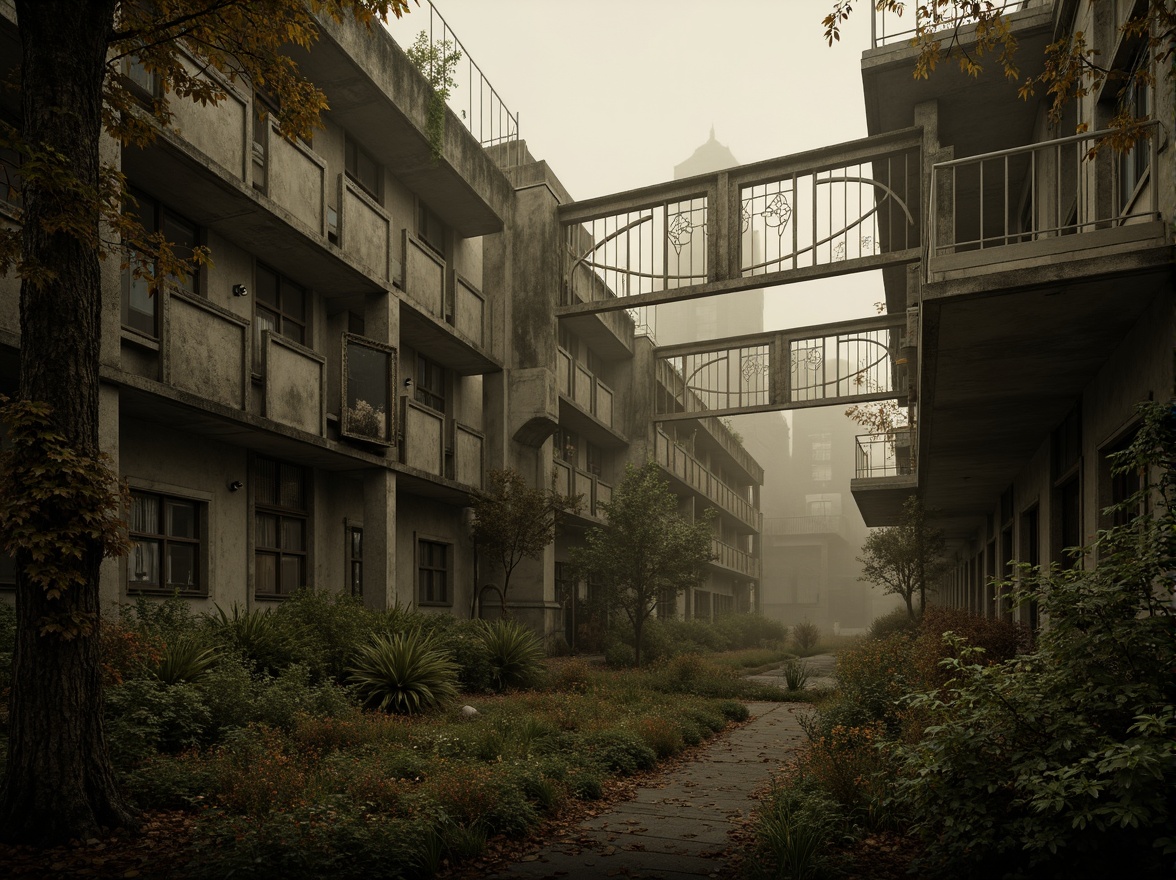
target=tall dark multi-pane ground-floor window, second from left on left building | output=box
[253,458,309,596]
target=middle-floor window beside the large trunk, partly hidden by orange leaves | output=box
[122,189,199,336]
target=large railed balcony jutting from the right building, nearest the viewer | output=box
[927,122,1168,292]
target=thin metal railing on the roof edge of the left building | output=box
[409,0,521,158]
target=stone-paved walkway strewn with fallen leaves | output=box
[477,655,833,880]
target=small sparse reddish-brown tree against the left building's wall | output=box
[470,468,580,615]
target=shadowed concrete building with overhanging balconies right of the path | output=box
[854,0,1176,625]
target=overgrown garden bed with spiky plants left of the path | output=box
[0,592,783,878]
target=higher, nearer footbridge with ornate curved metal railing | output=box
[556,128,923,318]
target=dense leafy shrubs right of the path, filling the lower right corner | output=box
[757,406,1176,880]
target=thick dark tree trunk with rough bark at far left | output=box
[0,0,132,844]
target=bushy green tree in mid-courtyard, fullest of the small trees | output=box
[572,461,714,666]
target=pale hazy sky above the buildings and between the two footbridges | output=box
[390,0,882,329]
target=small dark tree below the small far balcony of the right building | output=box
[857,495,947,620]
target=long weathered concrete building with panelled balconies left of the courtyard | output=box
[0,6,762,633]
